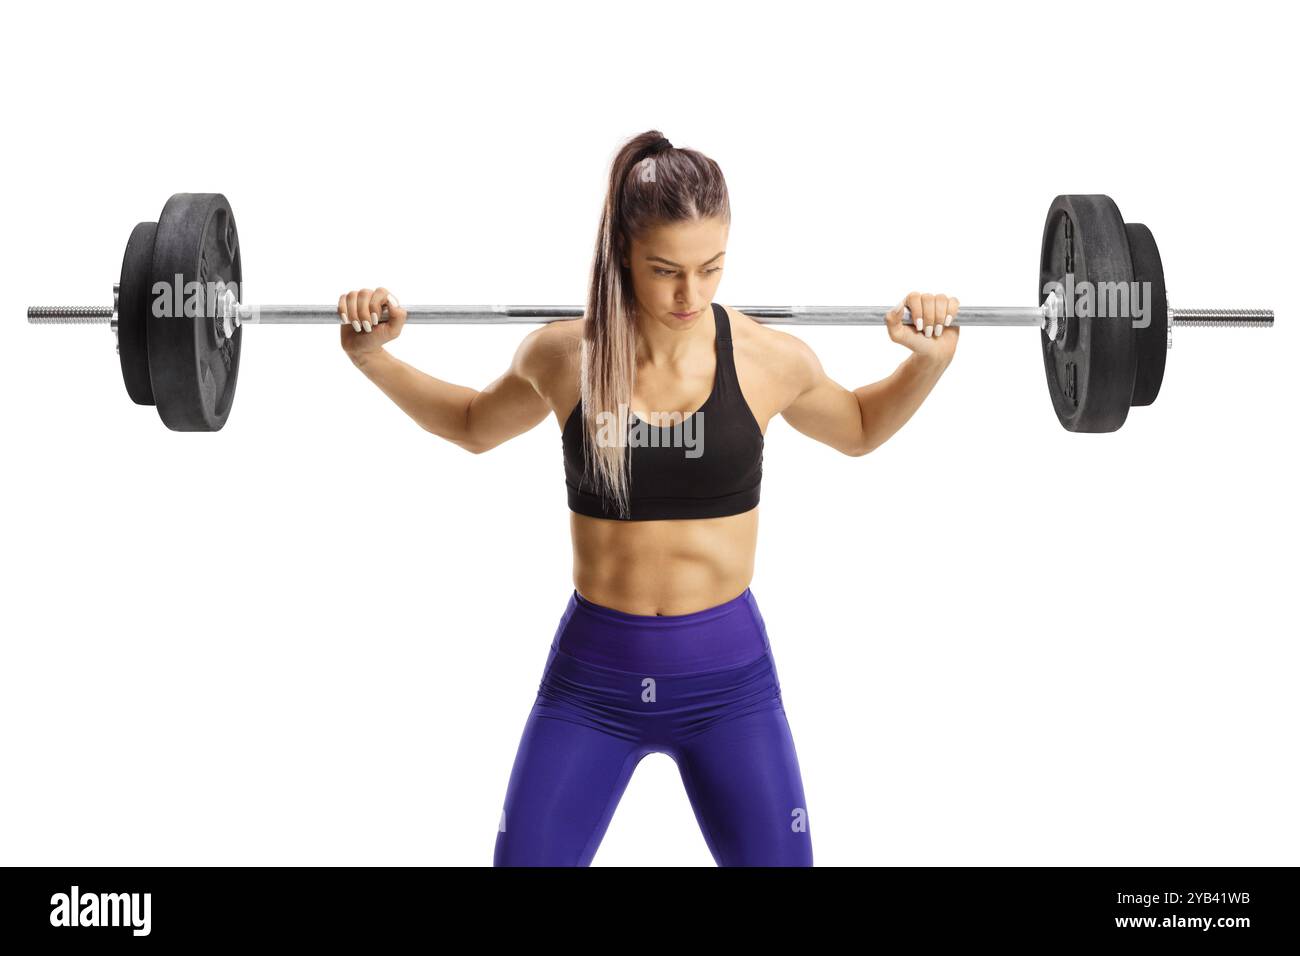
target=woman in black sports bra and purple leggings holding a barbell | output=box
[338,130,958,866]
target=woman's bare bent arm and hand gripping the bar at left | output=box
[338,289,550,454]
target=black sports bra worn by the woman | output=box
[562,303,763,522]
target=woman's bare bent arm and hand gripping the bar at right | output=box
[781,293,961,457]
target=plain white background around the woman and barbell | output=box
[0,0,1300,866]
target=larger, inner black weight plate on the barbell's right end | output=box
[1039,195,1136,432]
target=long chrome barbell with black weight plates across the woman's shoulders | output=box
[27,193,1273,432]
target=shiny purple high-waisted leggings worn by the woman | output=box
[493,588,813,866]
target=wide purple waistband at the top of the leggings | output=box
[551,588,770,675]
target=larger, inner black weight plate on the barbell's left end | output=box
[148,193,243,432]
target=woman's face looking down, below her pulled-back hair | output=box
[623,217,729,329]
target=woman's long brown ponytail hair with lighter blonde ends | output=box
[581,130,731,518]
